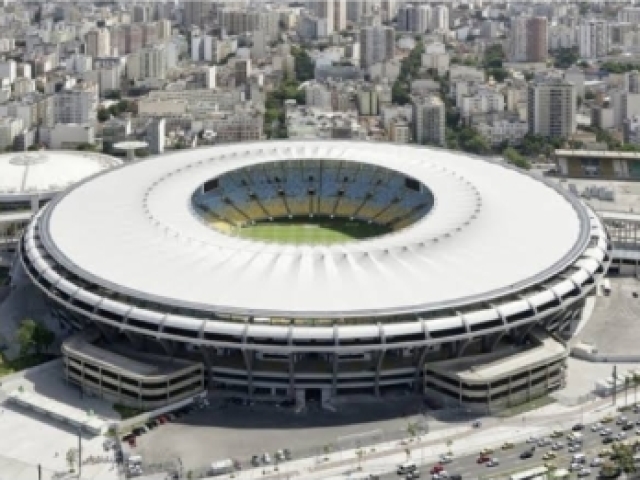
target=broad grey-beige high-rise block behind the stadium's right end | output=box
[527,78,576,138]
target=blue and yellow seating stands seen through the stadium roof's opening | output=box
[193,160,433,233]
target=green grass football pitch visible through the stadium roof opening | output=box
[236,218,391,245]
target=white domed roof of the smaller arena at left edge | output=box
[0,150,122,202]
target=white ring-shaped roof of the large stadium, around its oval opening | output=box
[40,141,589,318]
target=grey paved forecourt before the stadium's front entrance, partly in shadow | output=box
[130,396,451,472]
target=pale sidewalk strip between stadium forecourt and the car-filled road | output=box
[195,398,624,480]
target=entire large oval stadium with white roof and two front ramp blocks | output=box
[19,141,611,410]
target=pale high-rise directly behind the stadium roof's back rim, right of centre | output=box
[412,95,446,146]
